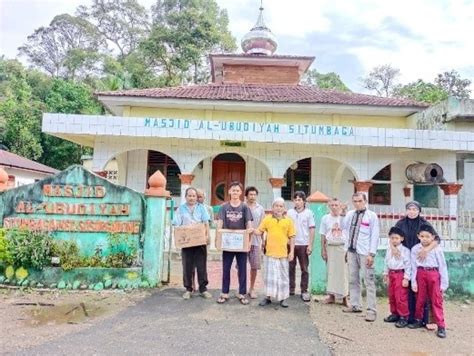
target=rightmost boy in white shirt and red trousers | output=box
[408,225,449,338]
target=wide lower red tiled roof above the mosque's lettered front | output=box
[96,84,428,108]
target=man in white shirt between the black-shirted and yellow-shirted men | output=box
[245,187,265,299]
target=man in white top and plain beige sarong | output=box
[319,198,349,306]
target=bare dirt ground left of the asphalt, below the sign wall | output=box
[0,289,149,354]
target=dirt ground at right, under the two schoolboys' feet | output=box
[311,296,474,356]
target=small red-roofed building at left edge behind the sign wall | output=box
[0,150,59,188]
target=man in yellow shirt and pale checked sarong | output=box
[254,198,296,308]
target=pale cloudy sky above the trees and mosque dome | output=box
[0,0,474,92]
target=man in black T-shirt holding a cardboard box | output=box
[217,182,253,305]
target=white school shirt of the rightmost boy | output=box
[411,244,449,291]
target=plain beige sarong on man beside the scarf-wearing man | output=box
[326,244,349,298]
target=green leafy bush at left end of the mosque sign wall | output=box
[6,229,52,269]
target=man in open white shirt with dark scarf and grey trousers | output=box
[343,193,380,321]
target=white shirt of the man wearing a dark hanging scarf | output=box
[343,209,380,256]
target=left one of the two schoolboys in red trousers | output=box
[383,227,411,328]
